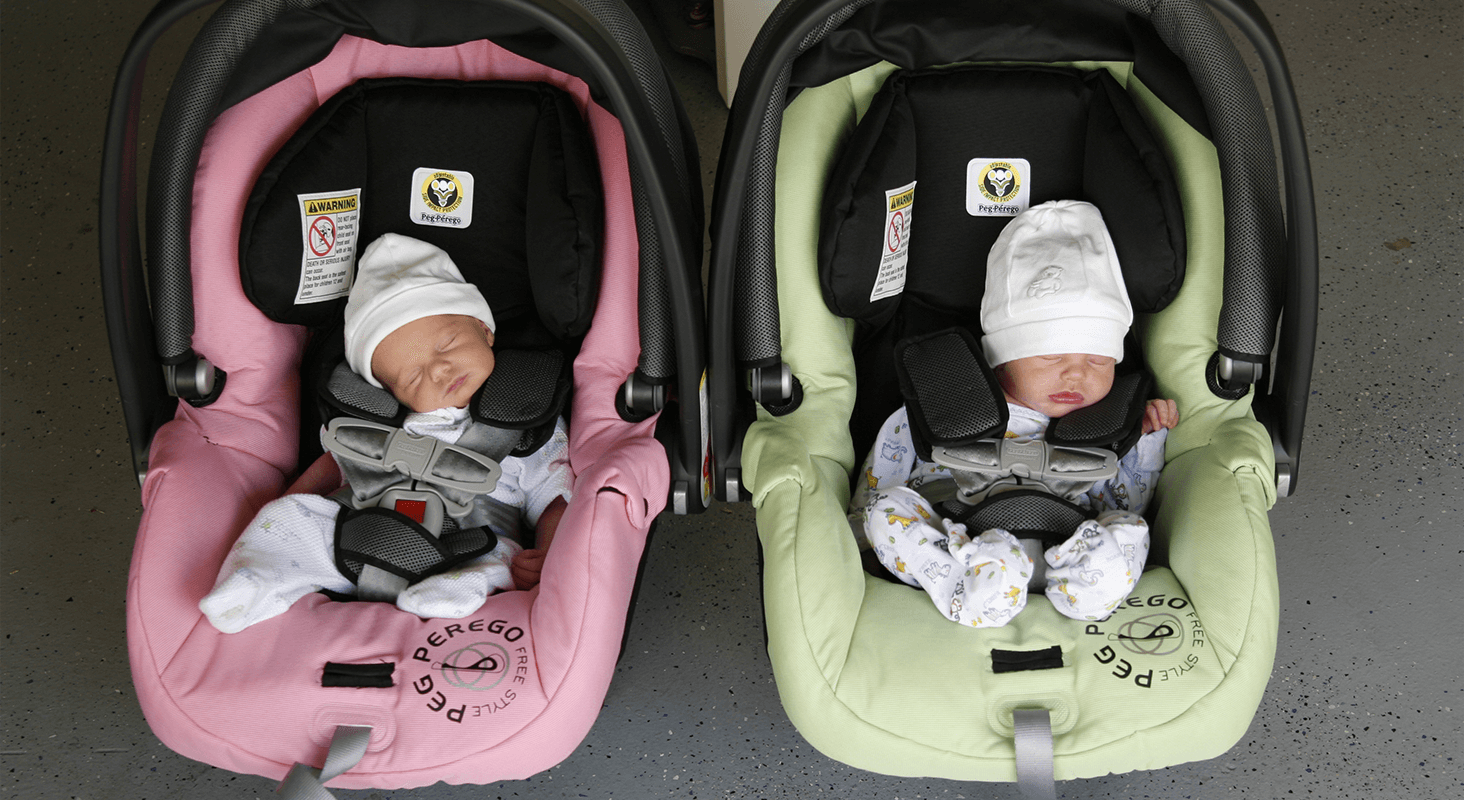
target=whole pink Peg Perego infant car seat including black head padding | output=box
[104,0,701,788]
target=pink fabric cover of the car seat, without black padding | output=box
[127,37,669,788]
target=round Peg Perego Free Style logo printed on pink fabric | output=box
[411,620,531,724]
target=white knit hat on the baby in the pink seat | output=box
[346,233,495,387]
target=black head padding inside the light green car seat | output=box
[818,66,1186,451]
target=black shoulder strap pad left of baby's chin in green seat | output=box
[895,328,1007,460]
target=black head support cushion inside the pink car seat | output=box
[240,78,603,349]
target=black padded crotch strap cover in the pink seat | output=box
[335,507,498,583]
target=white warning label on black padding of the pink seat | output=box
[294,189,362,305]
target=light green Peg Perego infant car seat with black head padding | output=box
[710,1,1315,781]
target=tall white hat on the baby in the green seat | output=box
[981,201,1133,366]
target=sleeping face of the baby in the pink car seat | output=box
[370,314,493,412]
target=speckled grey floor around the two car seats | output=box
[0,0,1464,800]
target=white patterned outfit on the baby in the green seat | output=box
[849,403,1168,627]
